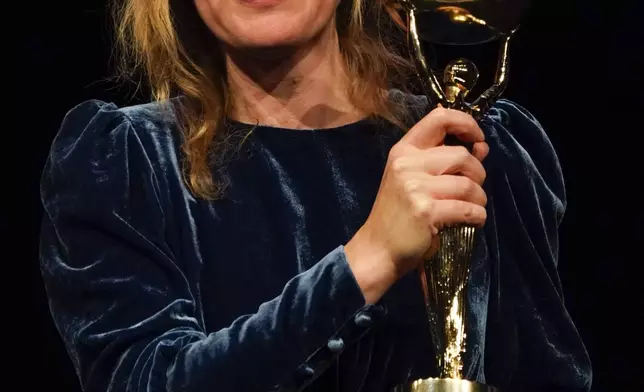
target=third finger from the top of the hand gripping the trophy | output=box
[423,175,487,207]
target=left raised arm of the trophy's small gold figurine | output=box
[405,7,449,107]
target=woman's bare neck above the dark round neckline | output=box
[226,23,365,129]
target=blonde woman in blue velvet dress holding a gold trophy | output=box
[41,0,590,392]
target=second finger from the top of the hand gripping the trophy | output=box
[392,146,486,184]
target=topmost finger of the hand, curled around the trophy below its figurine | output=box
[401,108,485,149]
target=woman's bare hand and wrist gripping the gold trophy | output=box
[345,108,489,303]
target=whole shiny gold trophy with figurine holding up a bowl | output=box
[387,0,530,392]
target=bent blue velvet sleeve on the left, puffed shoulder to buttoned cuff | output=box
[40,101,377,392]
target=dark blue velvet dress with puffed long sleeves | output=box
[40,93,591,392]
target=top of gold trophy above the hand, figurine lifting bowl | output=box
[384,0,532,120]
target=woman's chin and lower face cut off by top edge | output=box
[195,0,339,50]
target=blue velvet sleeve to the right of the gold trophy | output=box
[477,100,592,391]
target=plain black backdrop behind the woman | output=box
[17,0,644,392]
